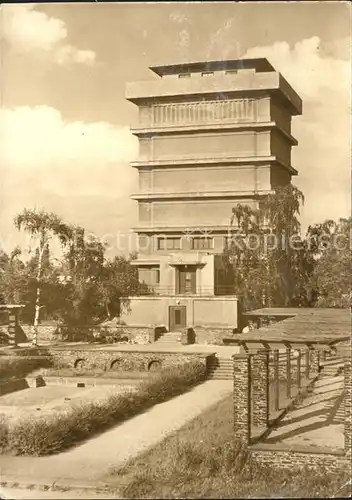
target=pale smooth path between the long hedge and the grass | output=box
[0,380,233,482]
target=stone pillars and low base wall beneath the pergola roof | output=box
[234,348,352,472]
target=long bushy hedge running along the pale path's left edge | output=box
[0,361,205,456]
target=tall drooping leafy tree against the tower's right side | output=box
[224,184,310,309]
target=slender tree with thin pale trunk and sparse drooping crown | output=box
[14,209,71,345]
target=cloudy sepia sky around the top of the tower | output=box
[0,1,351,253]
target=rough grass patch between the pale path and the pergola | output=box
[106,396,347,498]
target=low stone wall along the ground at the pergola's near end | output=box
[249,445,351,473]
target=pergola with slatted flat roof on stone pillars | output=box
[231,308,352,466]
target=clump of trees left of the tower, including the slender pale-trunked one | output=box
[0,209,140,328]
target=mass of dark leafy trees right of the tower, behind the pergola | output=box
[223,184,352,310]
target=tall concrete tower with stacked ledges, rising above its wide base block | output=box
[126,58,302,332]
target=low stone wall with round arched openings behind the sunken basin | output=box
[42,348,211,373]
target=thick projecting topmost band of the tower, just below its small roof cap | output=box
[125,71,302,115]
